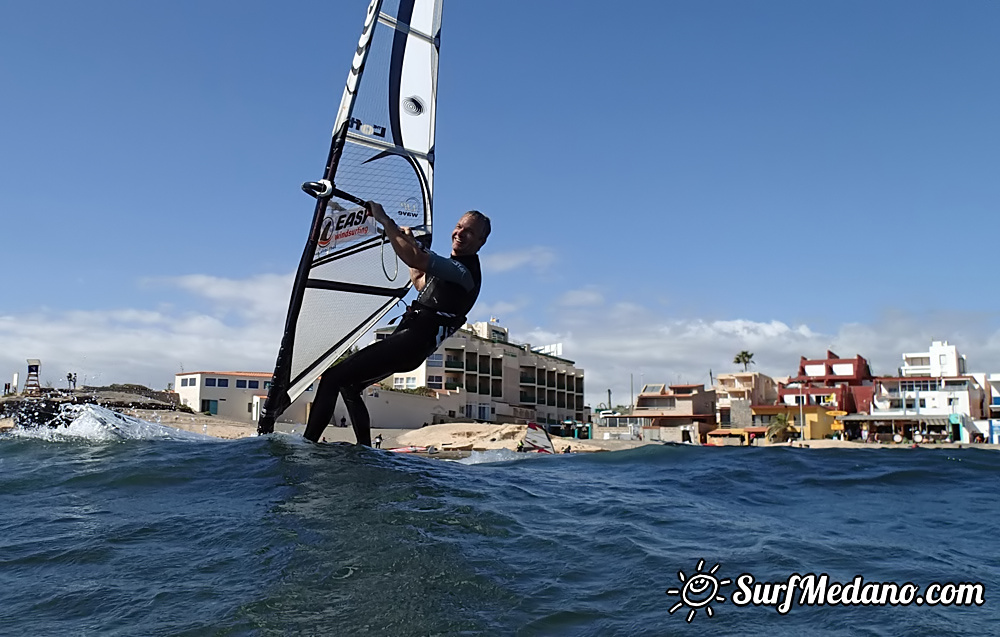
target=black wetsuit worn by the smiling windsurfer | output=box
[302,253,482,446]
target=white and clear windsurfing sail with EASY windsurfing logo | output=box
[257,0,442,434]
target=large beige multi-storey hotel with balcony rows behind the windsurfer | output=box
[375,321,589,425]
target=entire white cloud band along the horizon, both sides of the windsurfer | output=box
[0,275,1000,406]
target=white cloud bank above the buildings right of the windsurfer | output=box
[511,303,1000,406]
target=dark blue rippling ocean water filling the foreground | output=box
[0,407,1000,636]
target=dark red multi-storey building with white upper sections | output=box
[778,350,874,414]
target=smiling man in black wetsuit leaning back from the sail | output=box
[302,201,490,447]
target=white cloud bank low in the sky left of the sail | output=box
[0,275,291,388]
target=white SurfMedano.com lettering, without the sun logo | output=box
[732,573,986,615]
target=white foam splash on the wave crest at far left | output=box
[10,405,217,442]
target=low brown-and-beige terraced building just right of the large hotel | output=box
[594,384,715,444]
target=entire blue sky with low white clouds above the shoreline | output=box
[0,0,1000,409]
